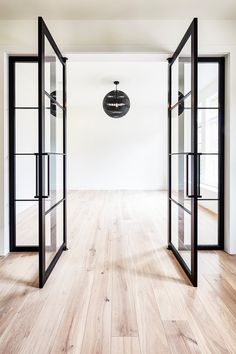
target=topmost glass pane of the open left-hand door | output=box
[45,37,63,106]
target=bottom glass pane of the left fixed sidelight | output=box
[16,202,38,246]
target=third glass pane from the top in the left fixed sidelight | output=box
[15,155,36,199]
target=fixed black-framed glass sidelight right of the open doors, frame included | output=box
[198,57,224,249]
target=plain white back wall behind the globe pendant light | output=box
[67,61,167,189]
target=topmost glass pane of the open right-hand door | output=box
[171,38,191,106]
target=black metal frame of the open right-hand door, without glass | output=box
[168,18,198,286]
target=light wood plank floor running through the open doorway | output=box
[0,192,236,354]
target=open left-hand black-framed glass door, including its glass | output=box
[36,17,66,287]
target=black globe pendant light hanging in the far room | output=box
[103,81,130,118]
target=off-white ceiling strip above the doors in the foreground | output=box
[0,0,236,20]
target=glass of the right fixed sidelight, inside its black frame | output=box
[198,63,219,245]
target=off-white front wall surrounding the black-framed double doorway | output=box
[0,20,236,254]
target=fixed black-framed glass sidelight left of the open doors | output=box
[9,56,39,252]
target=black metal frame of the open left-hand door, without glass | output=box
[38,17,67,288]
